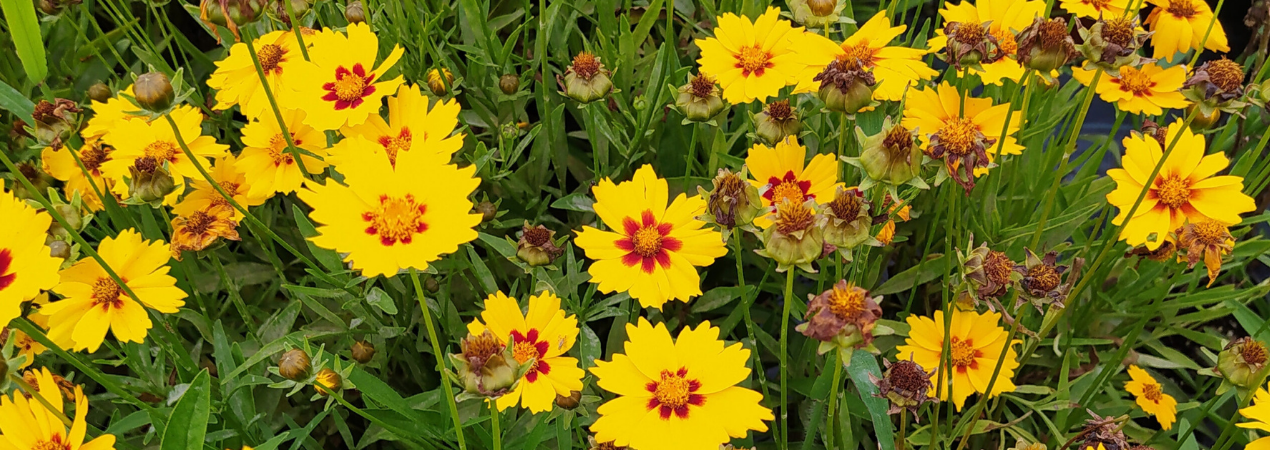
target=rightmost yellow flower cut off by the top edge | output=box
[1147,0,1231,61]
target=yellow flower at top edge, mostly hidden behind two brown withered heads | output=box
[928,0,1058,85]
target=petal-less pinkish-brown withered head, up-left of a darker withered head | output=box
[795,280,881,365]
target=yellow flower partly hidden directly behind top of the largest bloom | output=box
[335,84,464,167]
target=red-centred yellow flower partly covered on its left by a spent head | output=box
[467,291,585,413]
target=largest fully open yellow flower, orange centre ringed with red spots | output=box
[298,151,481,277]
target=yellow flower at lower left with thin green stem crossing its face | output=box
[41,229,185,352]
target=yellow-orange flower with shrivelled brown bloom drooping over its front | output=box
[900,83,1024,192]
